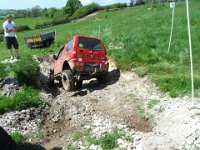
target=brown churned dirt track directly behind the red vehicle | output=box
[37,56,151,149]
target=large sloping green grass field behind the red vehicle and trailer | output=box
[0,0,200,96]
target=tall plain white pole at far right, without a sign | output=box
[186,0,194,98]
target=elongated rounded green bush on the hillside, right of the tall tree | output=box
[70,3,102,20]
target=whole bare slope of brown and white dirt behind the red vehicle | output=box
[37,58,200,150]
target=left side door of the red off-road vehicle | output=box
[54,46,64,75]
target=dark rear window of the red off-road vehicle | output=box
[78,37,102,51]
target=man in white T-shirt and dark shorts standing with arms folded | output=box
[3,15,20,60]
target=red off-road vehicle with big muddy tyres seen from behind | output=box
[49,35,109,91]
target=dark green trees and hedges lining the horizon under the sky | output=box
[14,0,186,18]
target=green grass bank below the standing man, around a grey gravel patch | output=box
[0,56,45,114]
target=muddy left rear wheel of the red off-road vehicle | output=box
[62,70,75,91]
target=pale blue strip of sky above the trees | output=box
[0,0,128,9]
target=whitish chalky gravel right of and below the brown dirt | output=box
[61,69,200,150]
